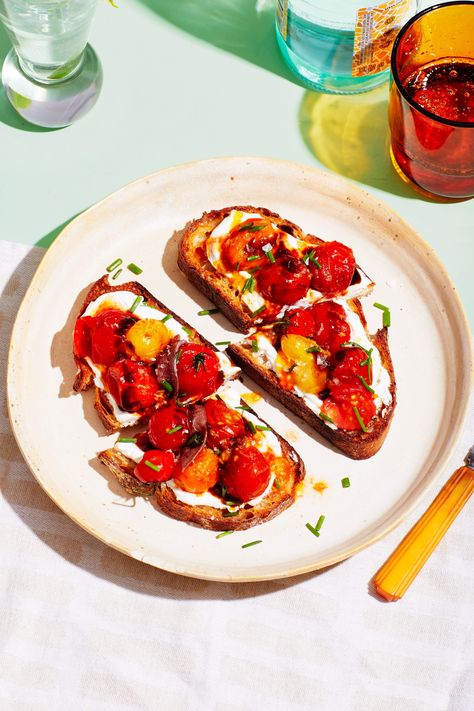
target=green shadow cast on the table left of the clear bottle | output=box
[140,0,303,86]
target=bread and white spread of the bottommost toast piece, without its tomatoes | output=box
[98,390,305,531]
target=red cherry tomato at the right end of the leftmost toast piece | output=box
[176,343,223,399]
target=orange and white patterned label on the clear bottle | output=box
[352,0,413,77]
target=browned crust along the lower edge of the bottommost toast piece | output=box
[98,411,305,531]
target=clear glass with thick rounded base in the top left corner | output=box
[0,0,102,127]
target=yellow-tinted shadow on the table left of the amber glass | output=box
[299,85,424,199]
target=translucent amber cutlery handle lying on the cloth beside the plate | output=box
[373,467,474,602]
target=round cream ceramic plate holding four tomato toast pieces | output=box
[8,158,471,581]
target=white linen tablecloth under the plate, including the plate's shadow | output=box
[0,242,474,711]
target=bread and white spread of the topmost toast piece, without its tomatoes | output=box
[178,205,374,333]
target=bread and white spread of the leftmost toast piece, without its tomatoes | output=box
[73,275,239,432]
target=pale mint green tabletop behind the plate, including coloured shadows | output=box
[0,0,474,325]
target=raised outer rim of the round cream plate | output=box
[7,156,474,583]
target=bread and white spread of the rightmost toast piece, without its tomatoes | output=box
[227,299,396,459]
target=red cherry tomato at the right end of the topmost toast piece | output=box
[309,242,356,296]
